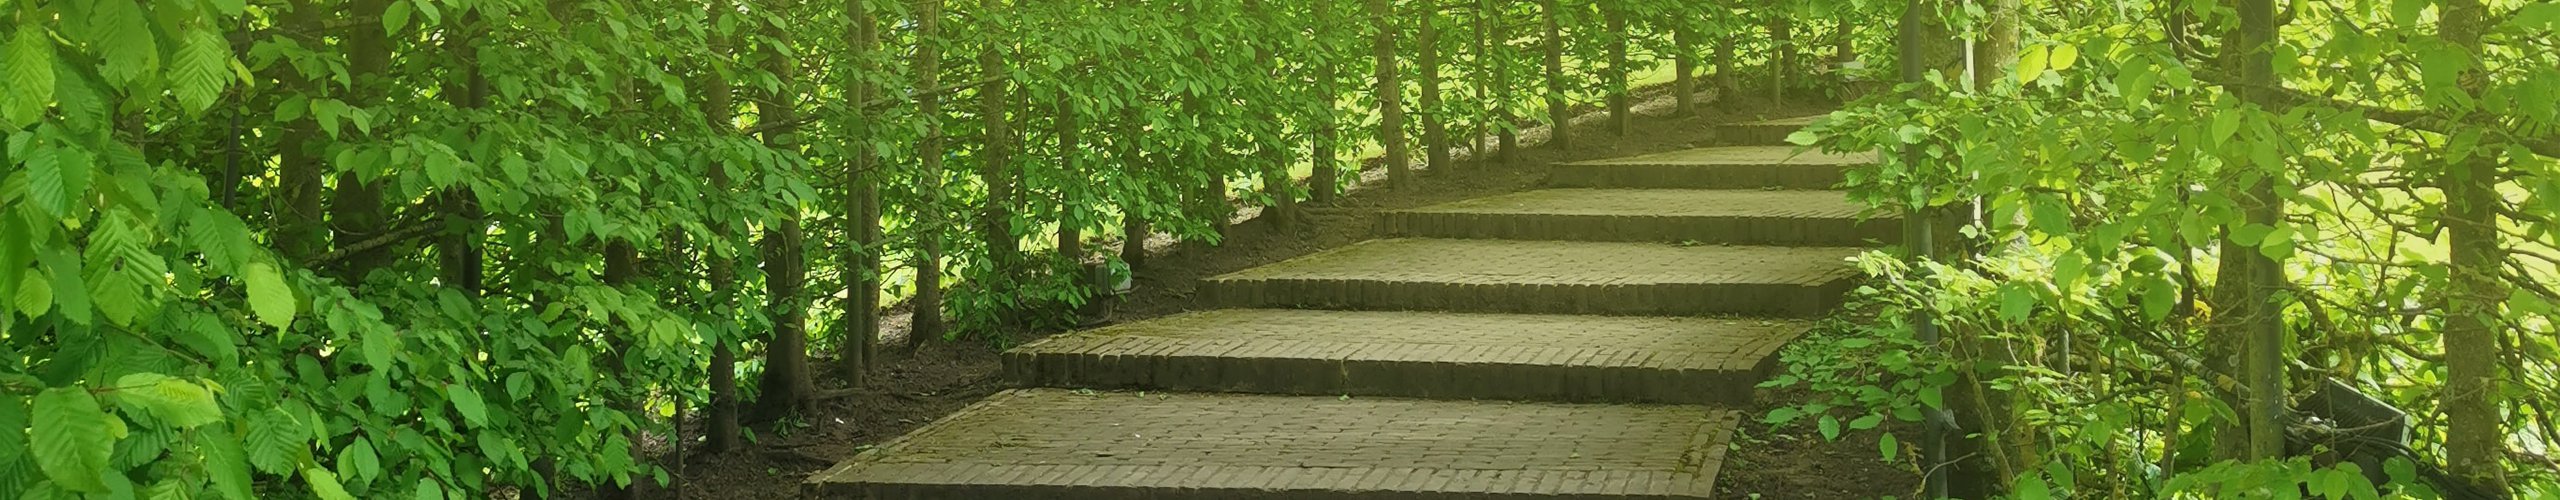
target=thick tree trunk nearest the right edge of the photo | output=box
[2437,0,2509,492]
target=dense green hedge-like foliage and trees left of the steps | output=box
[0,0,1848,497]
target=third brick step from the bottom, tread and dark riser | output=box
[1201,238,1859,318]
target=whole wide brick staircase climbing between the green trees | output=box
[804,121,1894,500]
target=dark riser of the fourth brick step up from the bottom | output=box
[1380,213,1900,246]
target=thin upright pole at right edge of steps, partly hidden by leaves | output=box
[1894,0,1951,497]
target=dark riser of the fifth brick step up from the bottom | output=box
[1546,164,1848,190]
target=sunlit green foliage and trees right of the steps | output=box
[1772,0,2560,497]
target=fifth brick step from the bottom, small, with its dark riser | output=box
[1546,146,1876,190]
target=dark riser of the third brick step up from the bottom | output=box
[1201,279,1851,318]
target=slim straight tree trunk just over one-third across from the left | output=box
[906,0,945,351]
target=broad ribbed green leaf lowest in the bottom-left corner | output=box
[28,387,123,492]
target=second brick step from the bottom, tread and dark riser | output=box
[1004,310,1807,405]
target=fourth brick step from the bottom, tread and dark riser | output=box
[1380,190,1900,246]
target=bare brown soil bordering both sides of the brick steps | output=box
[645,87,1917,500]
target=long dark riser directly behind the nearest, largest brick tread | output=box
[1004,348,1784,405]
